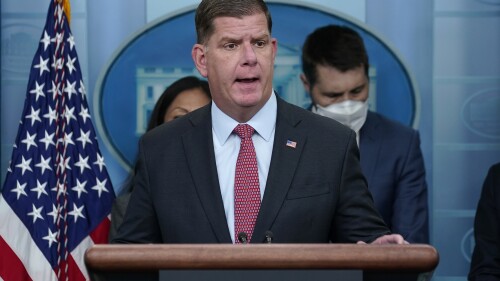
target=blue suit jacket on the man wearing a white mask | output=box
[360,111,429,243]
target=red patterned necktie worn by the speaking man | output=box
[234,124,260,243]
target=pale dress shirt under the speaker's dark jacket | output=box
[212,91,277,243]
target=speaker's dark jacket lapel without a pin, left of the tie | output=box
[183,105,232,243]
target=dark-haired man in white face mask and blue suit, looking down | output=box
[300,25,429,243]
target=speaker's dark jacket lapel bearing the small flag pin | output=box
[252,98,306,243]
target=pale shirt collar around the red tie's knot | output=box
[212,91,278,144]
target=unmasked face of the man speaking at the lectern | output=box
[192,13,277,122]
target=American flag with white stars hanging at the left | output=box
[0,0,115,281]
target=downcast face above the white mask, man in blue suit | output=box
[300,65,369,107]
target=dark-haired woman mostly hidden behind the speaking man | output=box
[109,76,212,241]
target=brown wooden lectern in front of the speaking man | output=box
[85,244,439,281]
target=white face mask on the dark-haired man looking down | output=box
[312,100,368,133]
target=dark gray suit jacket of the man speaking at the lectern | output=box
[114,98,389,243]
